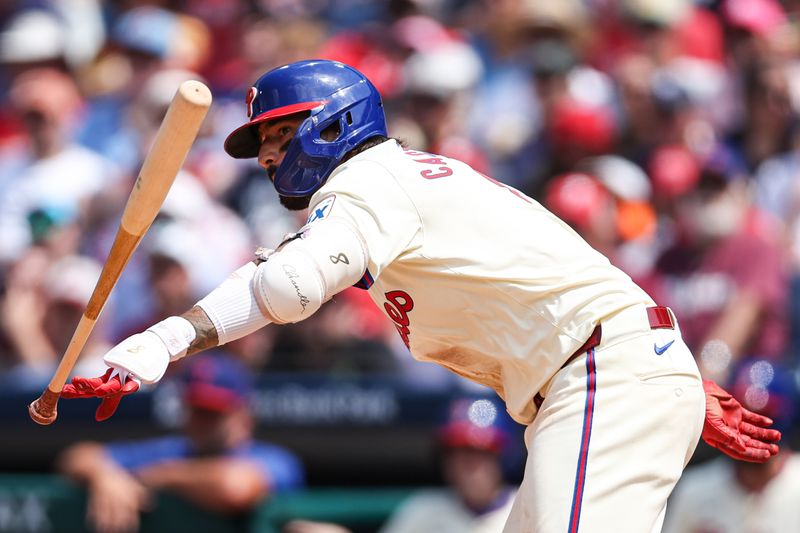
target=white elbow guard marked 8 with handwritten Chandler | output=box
[253,218,367,324]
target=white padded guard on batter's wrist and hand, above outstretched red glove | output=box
[103,316,196,383]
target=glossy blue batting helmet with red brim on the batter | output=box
[225,59,387,196]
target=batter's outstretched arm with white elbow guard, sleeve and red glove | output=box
[62,218,367,420]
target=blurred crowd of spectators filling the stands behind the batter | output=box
[0,0,800,528]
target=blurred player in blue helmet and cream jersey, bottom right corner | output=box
[664,359,800,533]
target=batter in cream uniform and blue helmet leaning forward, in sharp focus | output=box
[63,60,780,533]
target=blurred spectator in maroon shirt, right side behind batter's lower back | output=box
[644,147,788,381]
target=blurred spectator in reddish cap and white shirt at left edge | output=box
[0,69,119,265]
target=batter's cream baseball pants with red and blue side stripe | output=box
[504,305,705,533]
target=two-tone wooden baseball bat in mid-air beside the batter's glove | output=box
[28,80,211,425]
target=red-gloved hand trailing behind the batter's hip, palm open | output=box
[703,380,781,463]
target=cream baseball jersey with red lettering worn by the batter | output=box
[308,140,653,423]
